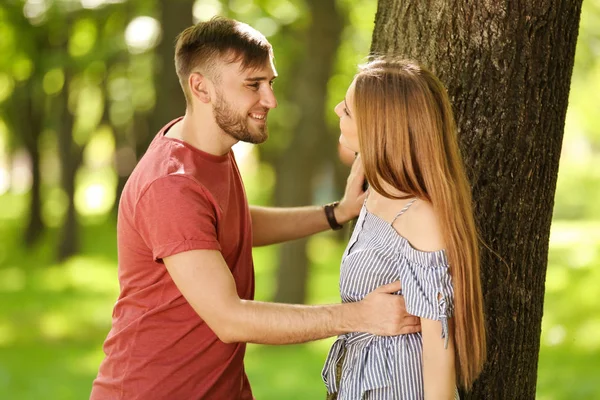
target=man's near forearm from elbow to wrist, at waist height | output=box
[217,300,364,344]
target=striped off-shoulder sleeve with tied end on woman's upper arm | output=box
[400,249,454,348]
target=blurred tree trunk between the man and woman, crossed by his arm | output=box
[275,0,344,303]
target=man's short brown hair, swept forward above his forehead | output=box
[175,17,273,104]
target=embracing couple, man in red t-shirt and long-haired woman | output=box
[91,18,485,400]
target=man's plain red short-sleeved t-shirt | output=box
[91,120,254,400]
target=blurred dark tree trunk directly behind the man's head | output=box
[143,0,194,156]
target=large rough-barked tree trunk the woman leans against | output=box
[372,0,582,399]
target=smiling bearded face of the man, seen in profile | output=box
[213,59,277,143]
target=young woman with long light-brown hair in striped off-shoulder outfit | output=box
[322,58,486,400]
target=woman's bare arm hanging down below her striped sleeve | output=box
[421,318,456,400]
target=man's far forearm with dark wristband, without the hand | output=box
[250,206,345,246]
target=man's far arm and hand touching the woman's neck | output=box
[250,159,365,246]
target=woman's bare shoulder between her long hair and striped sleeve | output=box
[394,200,445,251]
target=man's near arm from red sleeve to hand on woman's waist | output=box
[163,250,420,344]
